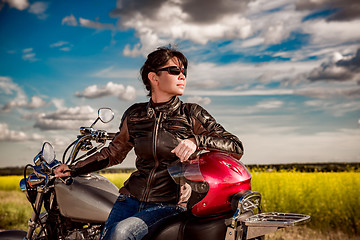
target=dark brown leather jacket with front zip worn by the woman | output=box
[72,97,243,203]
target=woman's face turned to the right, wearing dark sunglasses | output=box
[152,58,186,102]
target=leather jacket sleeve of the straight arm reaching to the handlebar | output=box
[70,114,133,176]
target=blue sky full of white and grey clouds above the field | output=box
[0,0,360,167]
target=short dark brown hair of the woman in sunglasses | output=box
[140,47,188,97]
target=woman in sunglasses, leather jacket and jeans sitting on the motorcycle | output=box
[56,48,243,239]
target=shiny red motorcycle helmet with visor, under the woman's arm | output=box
[169,152,251,216]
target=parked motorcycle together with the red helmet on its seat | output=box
[0,108,310,240]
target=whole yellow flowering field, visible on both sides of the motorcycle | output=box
[0,171,360,236]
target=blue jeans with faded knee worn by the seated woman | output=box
[100,193,185,240]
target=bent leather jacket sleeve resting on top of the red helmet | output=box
[190,104,244,159]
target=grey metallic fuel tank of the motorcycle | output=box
[55,173,119,223]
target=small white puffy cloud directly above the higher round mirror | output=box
[75,82,136,101]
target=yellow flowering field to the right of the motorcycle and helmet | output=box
[252,172,360,235]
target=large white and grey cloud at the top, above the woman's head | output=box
[113,0,306,56]
